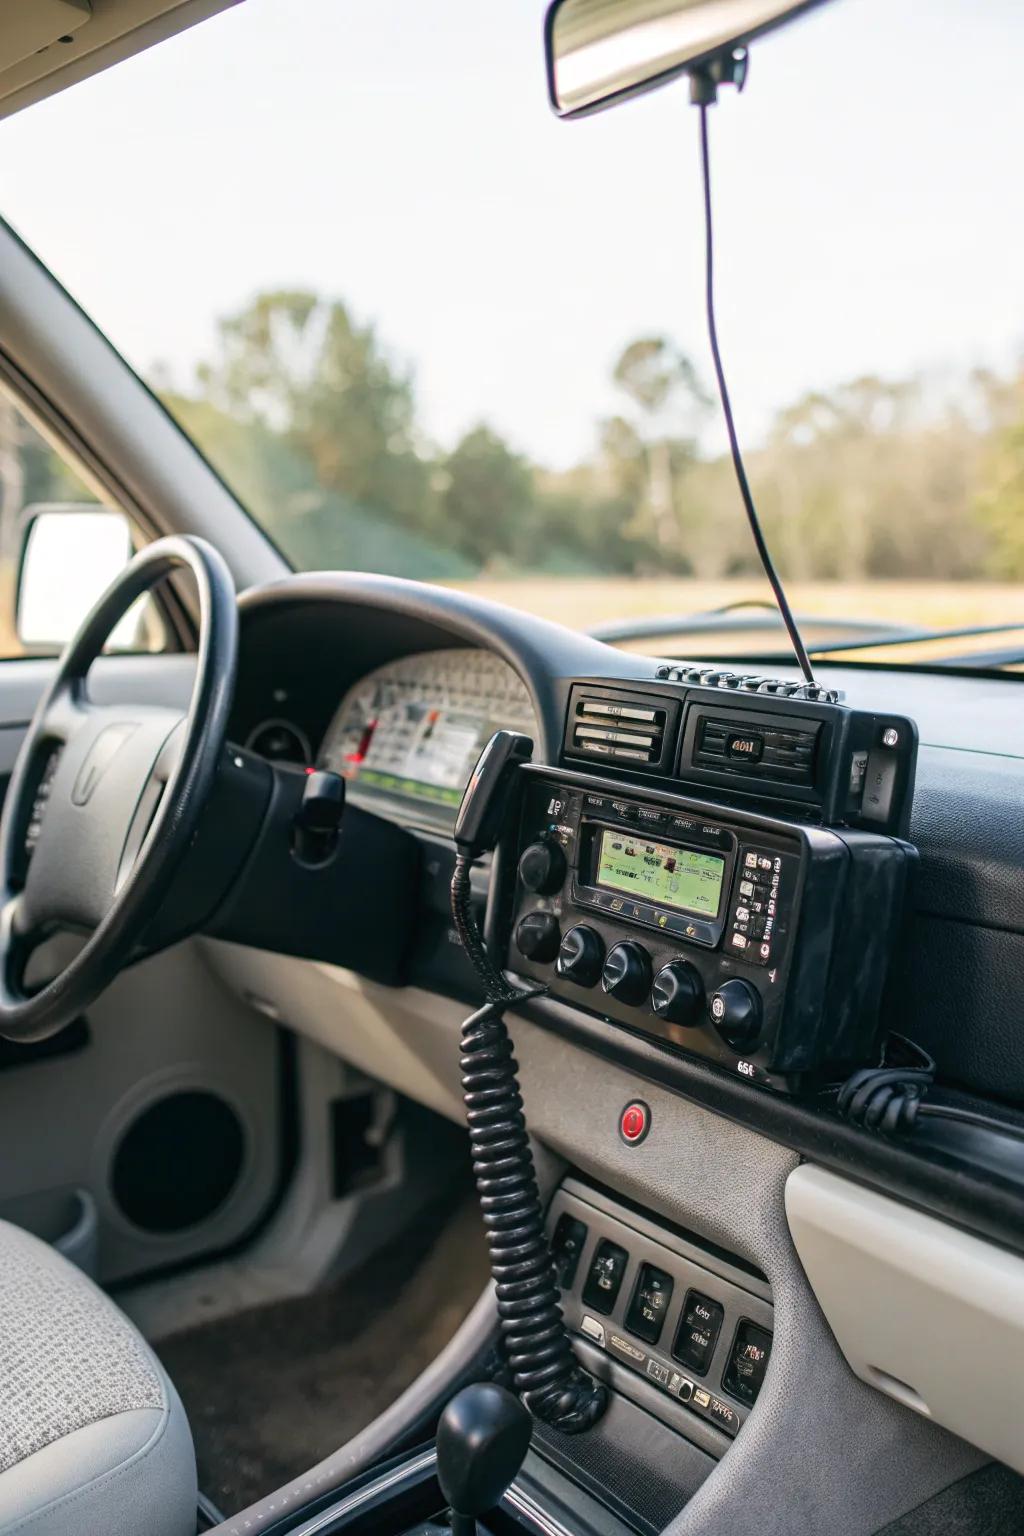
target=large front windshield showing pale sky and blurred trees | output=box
[0,0,1024,665]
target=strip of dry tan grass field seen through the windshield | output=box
[459,576,1024,660]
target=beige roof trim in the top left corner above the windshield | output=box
[0,0,238,117]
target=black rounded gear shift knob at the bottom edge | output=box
[438,1381,533,1536]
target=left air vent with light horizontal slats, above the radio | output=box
[565,684,679,773]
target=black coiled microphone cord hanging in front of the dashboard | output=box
[451,854,608,1435]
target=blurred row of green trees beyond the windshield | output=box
[148,290,1024,581]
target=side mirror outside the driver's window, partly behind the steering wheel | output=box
[15,502,146,651]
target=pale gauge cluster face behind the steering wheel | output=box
[321,650,536,822]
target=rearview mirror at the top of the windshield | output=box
[545,0,823,117]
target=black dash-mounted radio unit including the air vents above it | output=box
[499,674,915,1092]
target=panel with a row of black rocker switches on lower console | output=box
[548,1178,774,1456]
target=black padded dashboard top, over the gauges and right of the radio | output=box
[235,573,1024,1100]
